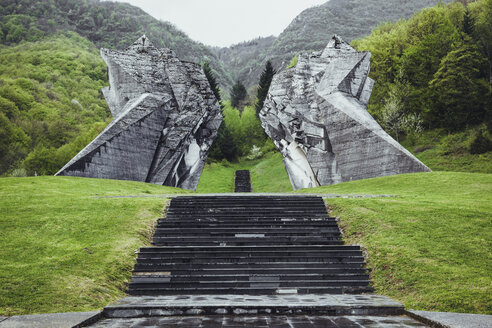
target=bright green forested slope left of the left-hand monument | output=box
[0,32,111,175]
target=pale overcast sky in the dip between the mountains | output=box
[105,0,327,47]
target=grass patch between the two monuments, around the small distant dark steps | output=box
[196,152,292,193]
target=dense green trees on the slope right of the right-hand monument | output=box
[352,0,492,154]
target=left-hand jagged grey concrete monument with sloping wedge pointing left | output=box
[56,36,222,189]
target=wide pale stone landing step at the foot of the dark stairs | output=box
[103,290,404,318]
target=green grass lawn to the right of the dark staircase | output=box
[301,172,492,314]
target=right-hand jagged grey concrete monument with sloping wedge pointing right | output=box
[260,36,430,189]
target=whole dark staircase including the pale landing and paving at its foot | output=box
[87,194,424,327]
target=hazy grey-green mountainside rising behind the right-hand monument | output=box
[221,0,451,88]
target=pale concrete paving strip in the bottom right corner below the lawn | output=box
[408,311,492,328]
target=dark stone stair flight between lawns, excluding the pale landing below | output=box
[129,196,372,295]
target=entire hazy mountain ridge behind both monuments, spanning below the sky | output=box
[0,0,451,93]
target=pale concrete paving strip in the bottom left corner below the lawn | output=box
[0,312,100,328]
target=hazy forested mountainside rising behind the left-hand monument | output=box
[0,0,233,86]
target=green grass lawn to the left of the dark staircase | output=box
[0,177,186,315]
